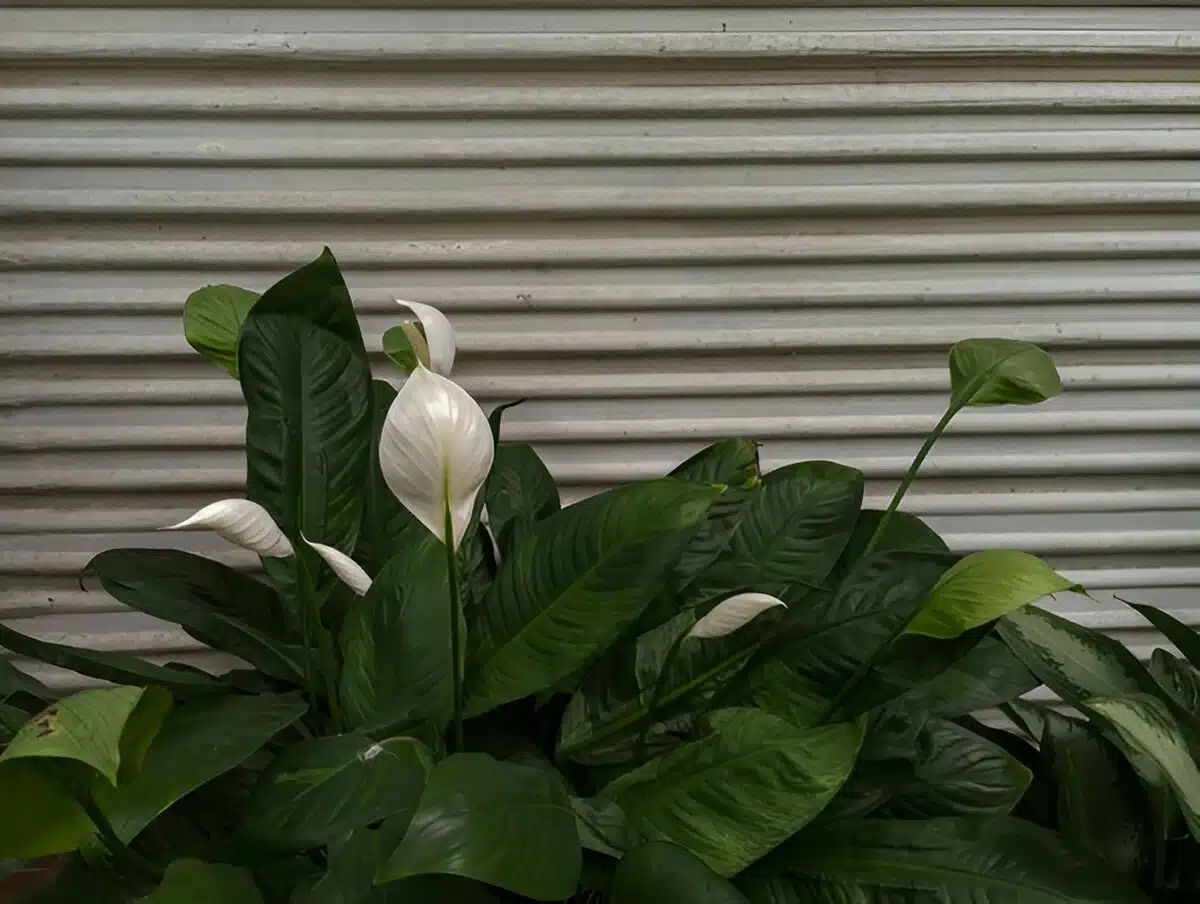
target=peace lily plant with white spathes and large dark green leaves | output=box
[0,250,1144,904]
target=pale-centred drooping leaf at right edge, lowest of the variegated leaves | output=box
[1085,694,1200,840]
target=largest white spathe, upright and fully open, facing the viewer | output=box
[379,367,494,550]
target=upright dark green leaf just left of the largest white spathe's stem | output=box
[341,531,454,728]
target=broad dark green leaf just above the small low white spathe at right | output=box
[695,461,863,601]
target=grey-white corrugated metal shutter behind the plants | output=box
[0,0,1200,682]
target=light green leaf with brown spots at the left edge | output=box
[0,688,170,785]
